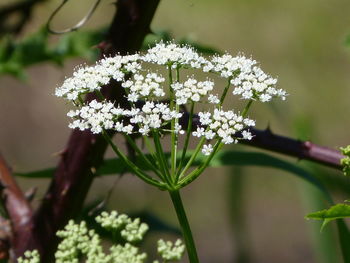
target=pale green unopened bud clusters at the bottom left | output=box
[18,211,185,263]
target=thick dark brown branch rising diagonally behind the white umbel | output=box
[7,0,159,262]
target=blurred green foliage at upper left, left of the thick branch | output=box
[0,28,104,79]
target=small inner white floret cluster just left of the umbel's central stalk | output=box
[122,73,165,102]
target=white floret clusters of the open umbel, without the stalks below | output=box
[55,42,287,155]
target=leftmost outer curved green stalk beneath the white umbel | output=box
[102,131,166,189]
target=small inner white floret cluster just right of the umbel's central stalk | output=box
[171,78,214,105]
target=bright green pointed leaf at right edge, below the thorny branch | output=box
[306,204,350,229]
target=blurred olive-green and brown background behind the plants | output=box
[0,0,350,263]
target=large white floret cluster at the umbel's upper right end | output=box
[203,54,287,102]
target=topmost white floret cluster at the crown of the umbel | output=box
[142,42,206,68]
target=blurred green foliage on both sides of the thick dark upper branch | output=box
[0,27,220,80]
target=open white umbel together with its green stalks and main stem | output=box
[55,42,287,263]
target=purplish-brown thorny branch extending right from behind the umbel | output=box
[241,129,344,169]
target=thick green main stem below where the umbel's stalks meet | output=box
[169,190,199,263]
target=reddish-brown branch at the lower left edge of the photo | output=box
[0,155,33,260]
